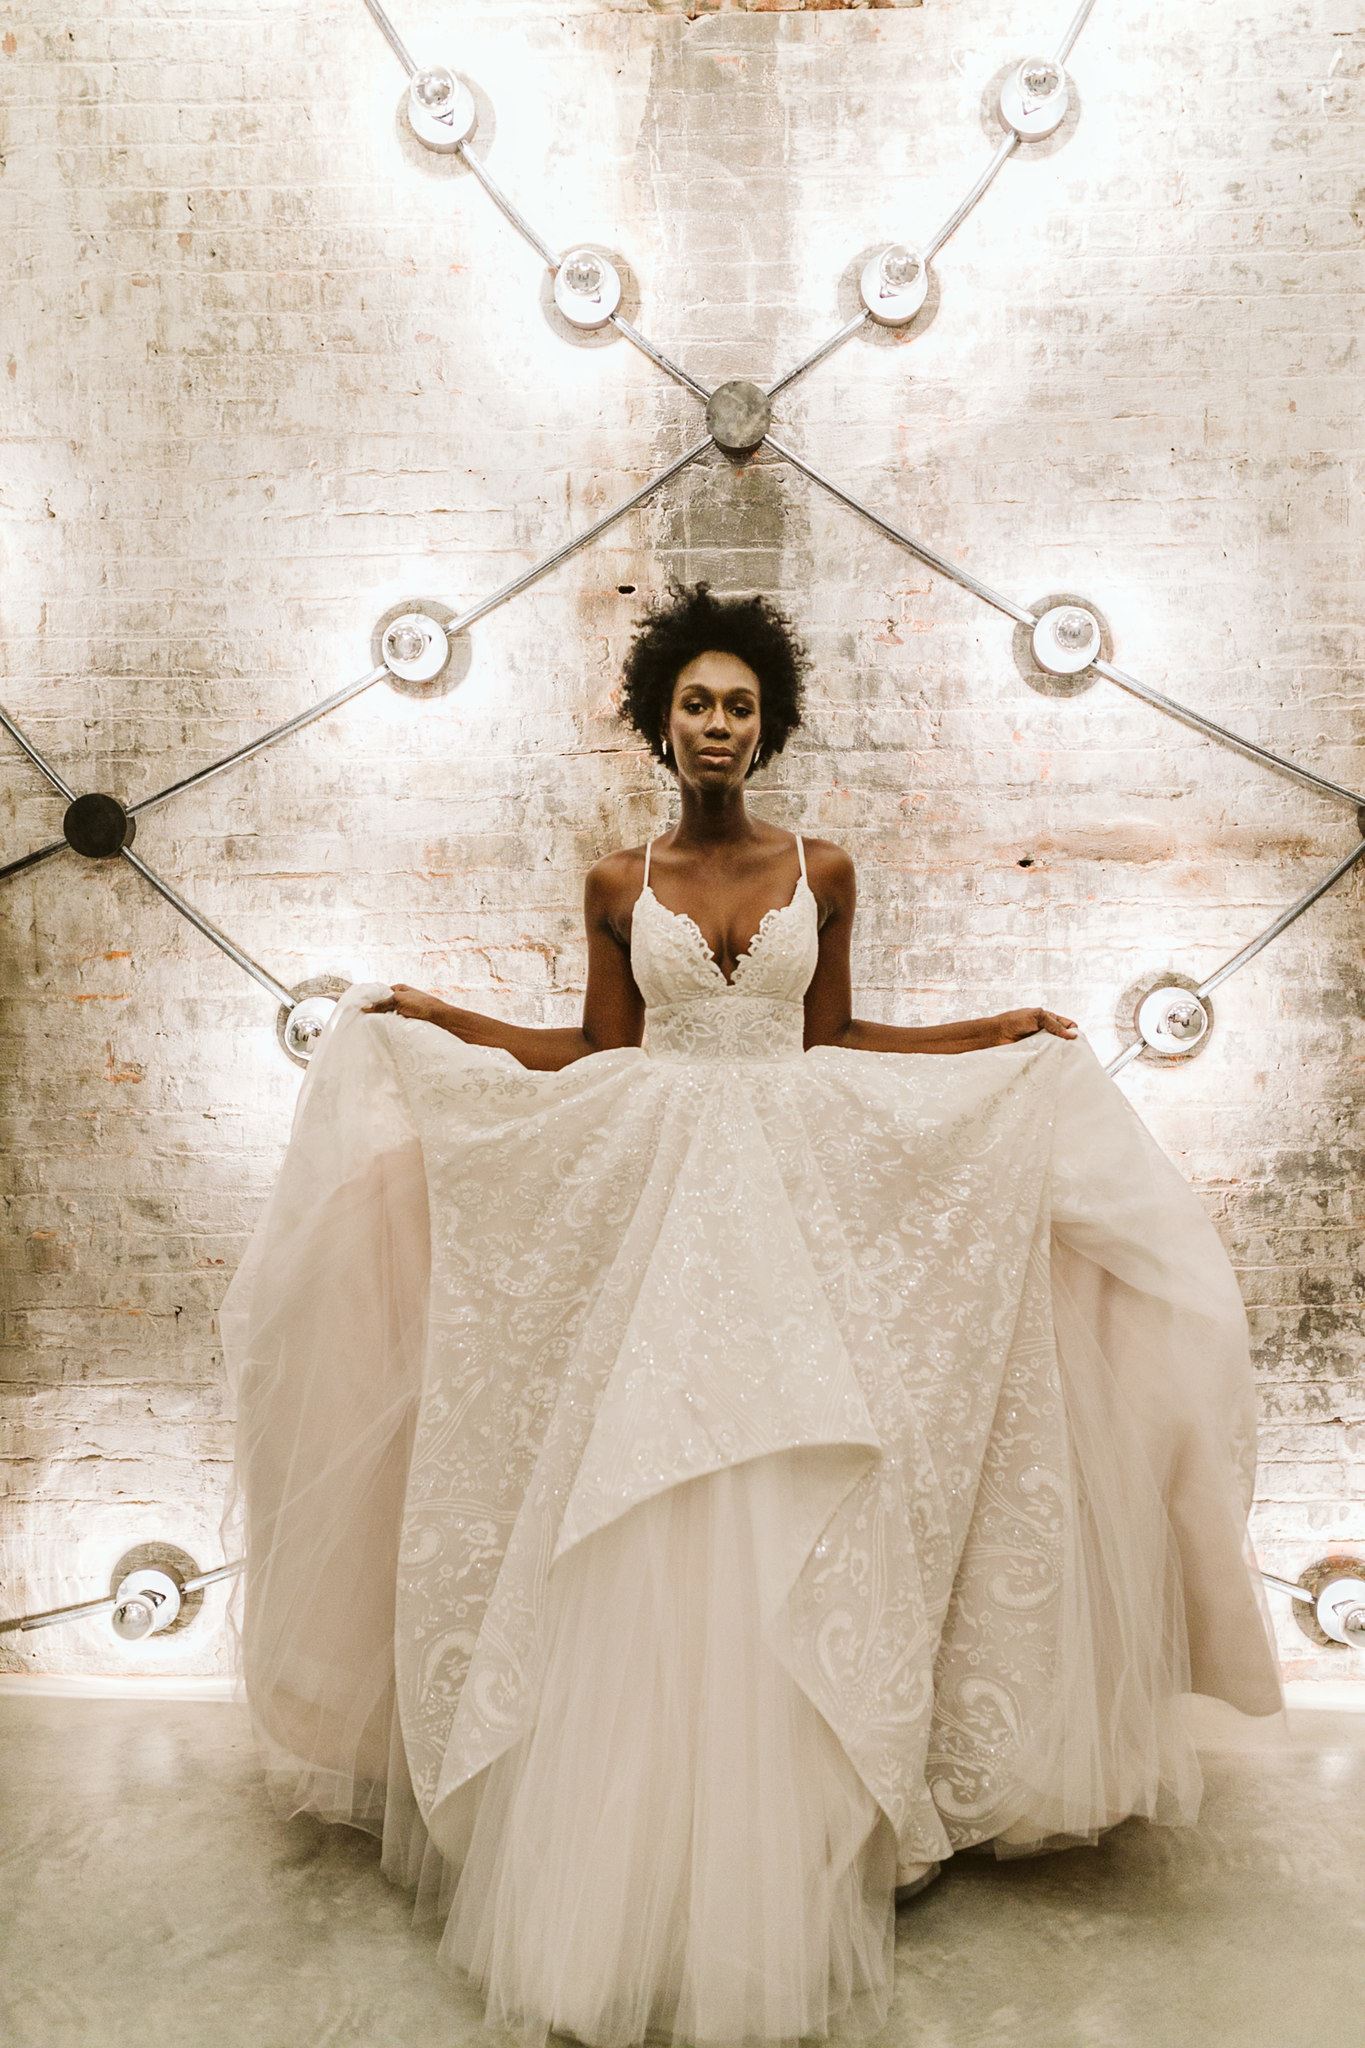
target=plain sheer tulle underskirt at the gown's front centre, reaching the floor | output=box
[383,1458,896,2048]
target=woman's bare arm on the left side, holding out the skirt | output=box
[364,854,645,1073]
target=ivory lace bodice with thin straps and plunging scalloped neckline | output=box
[630,834,819,1059]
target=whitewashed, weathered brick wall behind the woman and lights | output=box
[0,0,1365,1677]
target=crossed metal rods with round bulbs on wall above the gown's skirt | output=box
[0,0,1365,1073]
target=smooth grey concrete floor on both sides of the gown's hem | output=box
[0,1698,1365,2048]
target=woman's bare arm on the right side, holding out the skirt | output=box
[804,840,1076,1053]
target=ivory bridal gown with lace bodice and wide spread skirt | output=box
[219,840,1283,2048]
